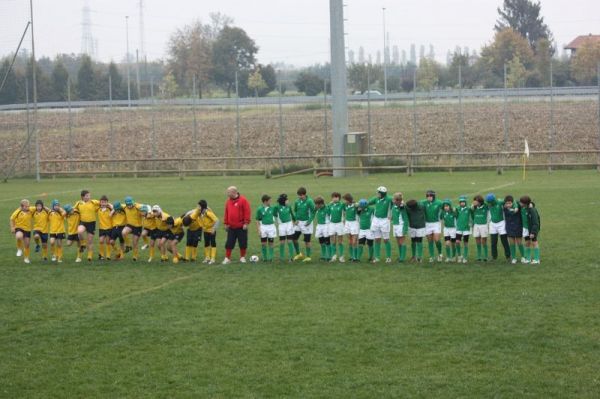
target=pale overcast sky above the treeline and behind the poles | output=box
[0,0,600,66]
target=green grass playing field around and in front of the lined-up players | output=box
[0,171,600,398]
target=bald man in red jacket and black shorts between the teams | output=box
[223,186,252,265]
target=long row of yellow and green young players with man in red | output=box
[10,186,540,264]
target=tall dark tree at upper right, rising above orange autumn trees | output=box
[495,0,552,51]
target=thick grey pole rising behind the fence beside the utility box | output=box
[329,0,348,177]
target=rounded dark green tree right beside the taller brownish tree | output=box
[212,26,258,97]
